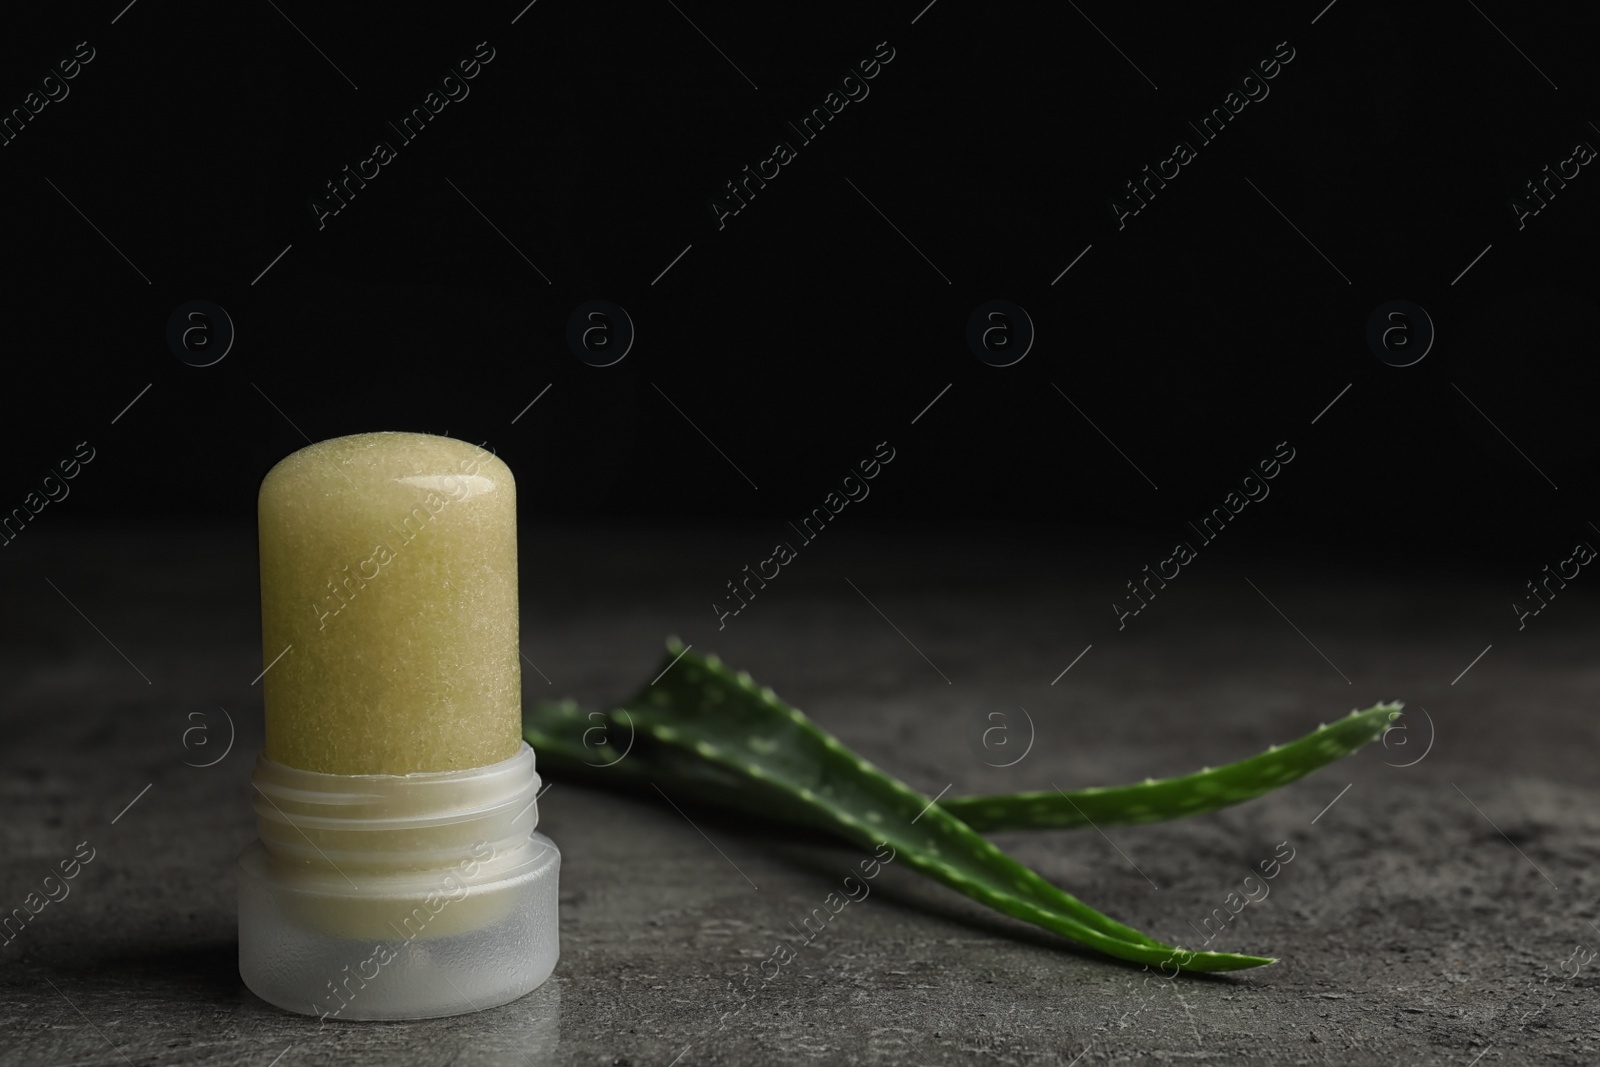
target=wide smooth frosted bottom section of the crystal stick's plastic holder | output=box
[237,833,562,1021]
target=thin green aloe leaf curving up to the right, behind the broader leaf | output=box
[939,704,1402,830]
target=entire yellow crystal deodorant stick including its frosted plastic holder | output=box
[238,434,560,1019]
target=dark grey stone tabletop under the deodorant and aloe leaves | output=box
[0,526,1600,1067]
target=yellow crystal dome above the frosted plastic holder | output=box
[259,434,522,774]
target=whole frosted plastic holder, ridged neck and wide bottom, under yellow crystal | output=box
[237,742,562,1021]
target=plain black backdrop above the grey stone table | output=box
[0,0,1600,572]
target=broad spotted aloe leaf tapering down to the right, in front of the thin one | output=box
[525,641,1274,971]
